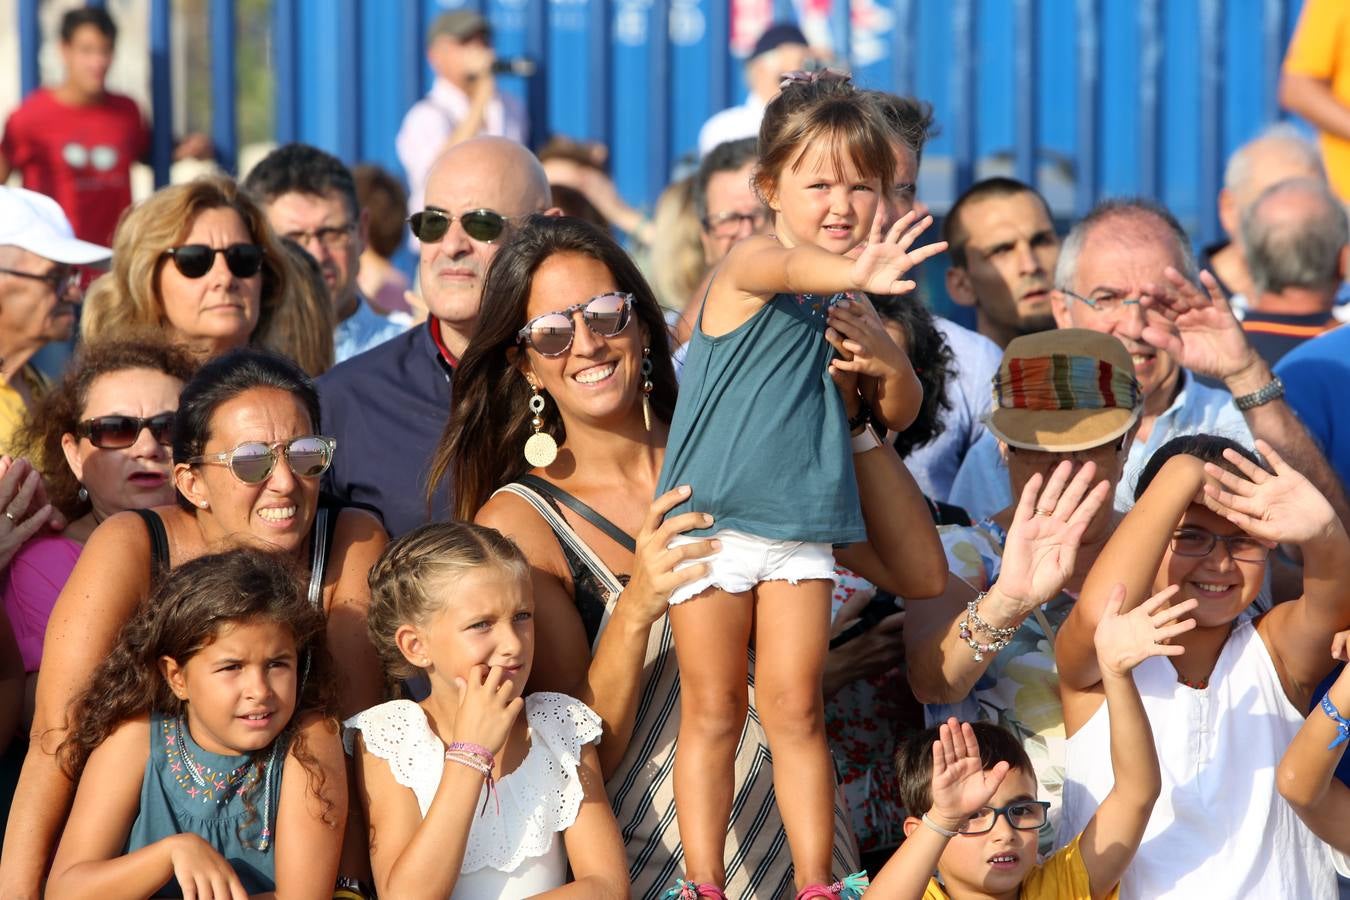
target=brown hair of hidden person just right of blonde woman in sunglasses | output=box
[254,237,336,378]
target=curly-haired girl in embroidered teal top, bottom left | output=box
[46,551,347,900]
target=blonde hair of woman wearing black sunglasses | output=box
[80,175,289,343]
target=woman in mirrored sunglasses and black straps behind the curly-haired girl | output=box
[4,351,386,890]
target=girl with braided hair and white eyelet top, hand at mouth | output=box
[346,522,628,900]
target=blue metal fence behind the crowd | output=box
[18,0,1317,240]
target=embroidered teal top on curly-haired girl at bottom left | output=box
[126,712,286,897]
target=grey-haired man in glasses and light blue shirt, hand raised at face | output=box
[952,200,1347,521]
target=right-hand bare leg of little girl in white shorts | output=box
[755,579,834,888]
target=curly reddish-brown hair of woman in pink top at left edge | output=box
[14,332,197,521]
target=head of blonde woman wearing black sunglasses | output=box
[81,177,290,360]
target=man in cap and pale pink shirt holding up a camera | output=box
[396,9,527,221]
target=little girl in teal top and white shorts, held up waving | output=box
[656,70,946,899]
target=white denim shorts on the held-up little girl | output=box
[670,529,834,606]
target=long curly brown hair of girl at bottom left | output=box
[57,549,338,822]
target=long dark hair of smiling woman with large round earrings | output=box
[427,216,676,521]
